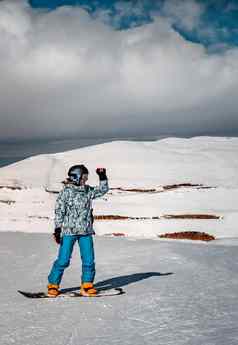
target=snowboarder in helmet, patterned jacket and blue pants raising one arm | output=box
[48,165,109,297]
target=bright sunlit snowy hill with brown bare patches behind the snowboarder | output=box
[0,137,238,238]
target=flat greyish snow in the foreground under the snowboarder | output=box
[0,233,238,345]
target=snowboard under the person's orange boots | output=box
[17,288,125,299]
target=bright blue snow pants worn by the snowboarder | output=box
[48,235,95,285]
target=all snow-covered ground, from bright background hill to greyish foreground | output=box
[0,137,238,345]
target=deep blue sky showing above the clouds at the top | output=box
[29,0,238,48]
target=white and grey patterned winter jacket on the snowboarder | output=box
[55,180,109,235]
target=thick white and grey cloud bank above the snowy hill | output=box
[0,0,238,140]
